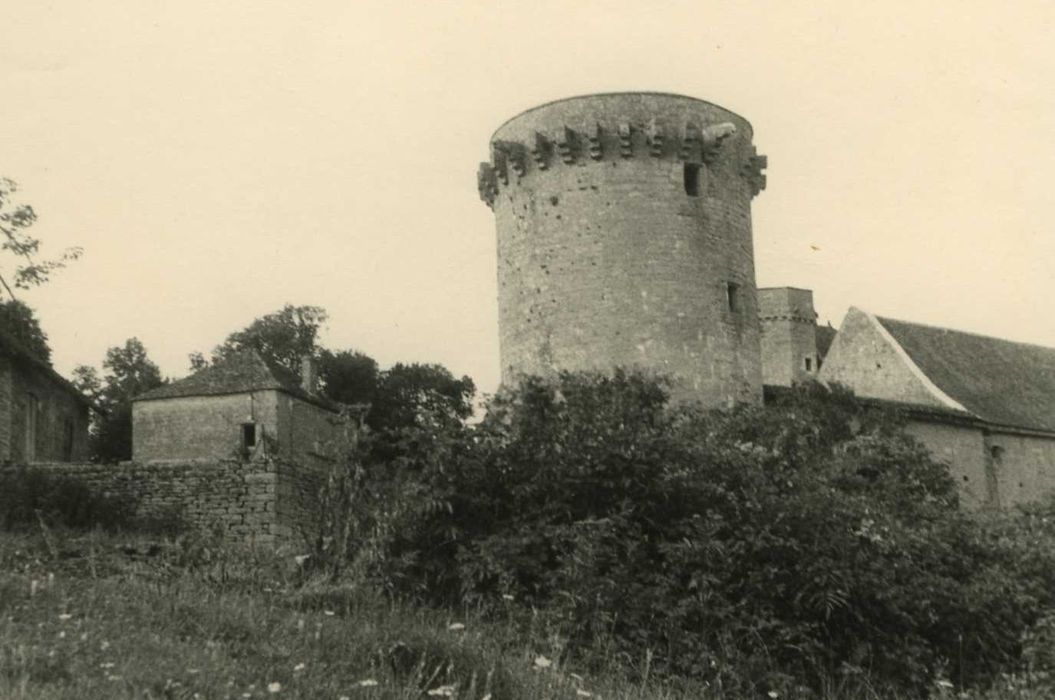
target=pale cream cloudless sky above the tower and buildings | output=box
[0,0,1055,391]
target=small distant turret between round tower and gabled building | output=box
[759,287,820,387]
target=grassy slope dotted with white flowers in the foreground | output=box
[0,530,1046,700]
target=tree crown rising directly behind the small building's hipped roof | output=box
[212,304,328,373]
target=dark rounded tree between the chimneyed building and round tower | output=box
[366,363,476,430]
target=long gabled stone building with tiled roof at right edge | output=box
[820,308,1055,507]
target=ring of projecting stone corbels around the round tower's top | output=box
[477,117,766,207]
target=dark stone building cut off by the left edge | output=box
[0,329,91,464]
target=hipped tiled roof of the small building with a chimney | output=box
[134,350,337,411]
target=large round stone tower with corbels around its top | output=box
[478,93,766,406]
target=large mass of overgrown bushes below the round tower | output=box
[316,372,1055,696]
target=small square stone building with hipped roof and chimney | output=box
[132,351,348,463]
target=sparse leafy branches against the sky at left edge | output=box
[0,178,82,298]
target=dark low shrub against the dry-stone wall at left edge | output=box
[0,468,136,531]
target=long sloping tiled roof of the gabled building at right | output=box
[877,316,1055,432]
